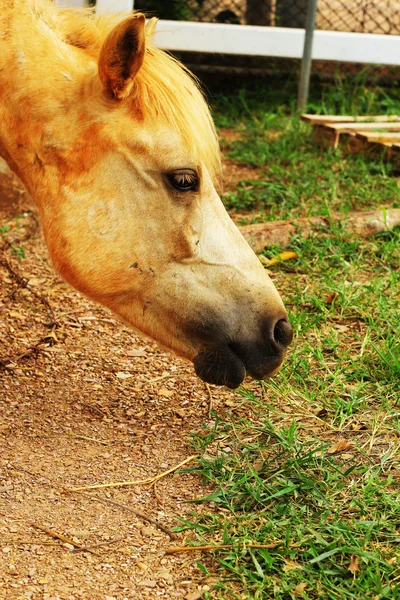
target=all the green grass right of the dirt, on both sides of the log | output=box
[180,82,400,600]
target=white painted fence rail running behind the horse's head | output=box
[56,0,400,65]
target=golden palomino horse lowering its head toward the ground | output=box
[0,0,292,388]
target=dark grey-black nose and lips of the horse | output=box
[193,318,293,389]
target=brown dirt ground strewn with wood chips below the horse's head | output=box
[0,159,266,600]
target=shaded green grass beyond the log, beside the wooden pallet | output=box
[214,75,400,220]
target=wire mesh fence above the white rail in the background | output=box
[135,0,400,35]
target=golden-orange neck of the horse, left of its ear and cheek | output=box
[0,0,90,192]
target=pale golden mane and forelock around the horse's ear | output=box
[51,6,221,180]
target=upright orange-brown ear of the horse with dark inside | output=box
[99,13,146,100]
